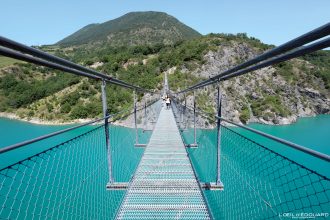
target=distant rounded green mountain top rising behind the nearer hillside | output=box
[57,11,200,46]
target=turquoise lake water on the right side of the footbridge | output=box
[183,115,330,219]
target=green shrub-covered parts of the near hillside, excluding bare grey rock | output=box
[0,34,330,121]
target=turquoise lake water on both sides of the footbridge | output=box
[0,115,330,219]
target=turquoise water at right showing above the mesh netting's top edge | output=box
[235,115,330,177]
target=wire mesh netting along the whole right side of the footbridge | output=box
[174,98,330,219]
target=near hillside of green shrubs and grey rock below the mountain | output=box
[0,12,330,126]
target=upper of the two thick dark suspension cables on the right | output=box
[179,23,330,93]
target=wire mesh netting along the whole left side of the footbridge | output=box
[0,100,159,219]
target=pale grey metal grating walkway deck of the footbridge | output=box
[117,108,210,219]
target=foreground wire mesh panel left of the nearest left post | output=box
[0,126,120,219]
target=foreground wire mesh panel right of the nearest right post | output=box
[216,127,330,219]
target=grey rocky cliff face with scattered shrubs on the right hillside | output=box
[174,43,330,127]
